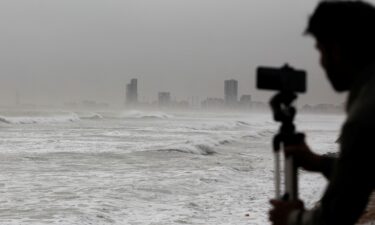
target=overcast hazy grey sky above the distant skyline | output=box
[0,0,374,105]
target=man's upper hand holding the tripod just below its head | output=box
[284,143,322,172]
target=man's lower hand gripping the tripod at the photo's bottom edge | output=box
[269,199,304,225]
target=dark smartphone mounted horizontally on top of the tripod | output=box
[256,64,306,93]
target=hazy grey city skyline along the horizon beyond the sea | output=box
[5,75,345,109]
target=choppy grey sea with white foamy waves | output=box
[0,110,344,225]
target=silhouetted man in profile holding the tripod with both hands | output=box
[269,1,375,225]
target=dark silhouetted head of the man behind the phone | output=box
[306,0,375,91]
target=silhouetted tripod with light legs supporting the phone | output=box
[270,91,304,201]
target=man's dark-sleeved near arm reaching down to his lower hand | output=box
[289,121,375,225]
